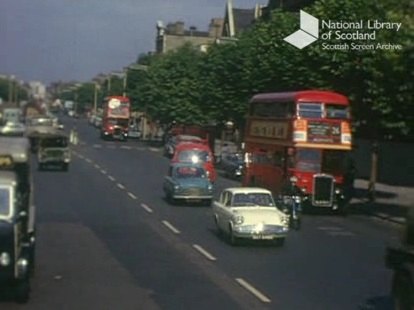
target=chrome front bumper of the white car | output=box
[233,225,289,240]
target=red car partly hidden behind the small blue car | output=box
[171,142,217,182]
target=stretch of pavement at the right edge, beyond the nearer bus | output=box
[351,179,414,224]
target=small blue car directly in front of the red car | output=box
[163,163,213,205]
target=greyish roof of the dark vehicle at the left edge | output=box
[0,137,30,162]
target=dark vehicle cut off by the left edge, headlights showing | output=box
[0,138,35,302]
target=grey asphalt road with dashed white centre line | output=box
[0,115,399,310]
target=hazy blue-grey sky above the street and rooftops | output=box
[0,0,267,84]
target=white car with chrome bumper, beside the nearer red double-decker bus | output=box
[213,187,289,245]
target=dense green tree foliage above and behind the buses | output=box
[124,0,414,138]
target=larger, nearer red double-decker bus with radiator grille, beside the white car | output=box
[242,90,353,210]
